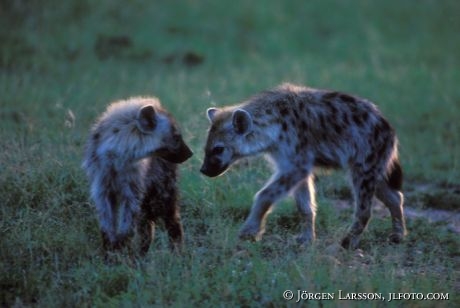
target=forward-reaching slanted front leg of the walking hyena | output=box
[239,170,307,240]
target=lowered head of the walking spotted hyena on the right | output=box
[200,108,253,177]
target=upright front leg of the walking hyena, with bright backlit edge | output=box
[294,174,316,244]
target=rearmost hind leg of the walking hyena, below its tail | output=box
[375,181,407,243]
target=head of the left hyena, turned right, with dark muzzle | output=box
[136,105,193,164]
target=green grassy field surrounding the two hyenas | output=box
[0,0,460,307]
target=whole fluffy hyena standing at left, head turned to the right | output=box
[83,97,192,254]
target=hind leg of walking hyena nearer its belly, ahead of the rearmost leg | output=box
[342,169,376,249]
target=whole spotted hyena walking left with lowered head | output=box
[201,84,406,248]
